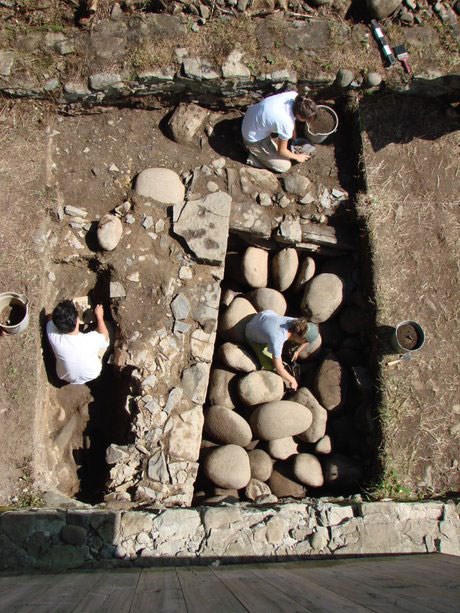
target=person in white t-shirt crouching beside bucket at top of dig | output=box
[241,92,317,172]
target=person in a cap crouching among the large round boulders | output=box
[245,310,319,391]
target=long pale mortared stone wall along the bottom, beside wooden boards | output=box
[0,499,460,570]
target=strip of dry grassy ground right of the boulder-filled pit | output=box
[363,100,460,497]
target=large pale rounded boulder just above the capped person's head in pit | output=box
[301,272,344,323]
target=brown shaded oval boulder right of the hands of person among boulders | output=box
[314,353,348,411]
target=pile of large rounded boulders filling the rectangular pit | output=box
[195,241,371,503]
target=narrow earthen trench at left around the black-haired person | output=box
[43,258,132,504]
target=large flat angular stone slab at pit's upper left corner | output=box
[173,192,232,264]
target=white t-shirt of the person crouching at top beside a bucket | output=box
[241,92,298,143]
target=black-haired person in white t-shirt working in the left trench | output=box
[46,300,109,384]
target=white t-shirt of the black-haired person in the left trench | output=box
[46,321,109,383]
